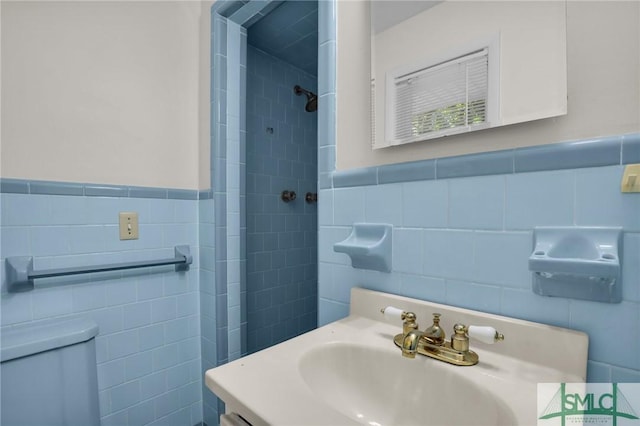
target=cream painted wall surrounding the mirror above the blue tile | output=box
[337,1,640,170]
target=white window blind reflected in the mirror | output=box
[390,49,489,145]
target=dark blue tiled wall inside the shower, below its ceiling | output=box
[246,46,318,353]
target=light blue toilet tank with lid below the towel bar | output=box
[0,318,100,426]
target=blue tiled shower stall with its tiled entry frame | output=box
[205,0,328,424]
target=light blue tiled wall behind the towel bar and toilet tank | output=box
[0,193,201,425]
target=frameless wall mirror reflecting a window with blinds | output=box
[371,0,567,149]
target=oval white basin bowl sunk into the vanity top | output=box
[299,343,517,426]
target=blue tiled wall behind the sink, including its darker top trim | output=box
[318,134,640,382]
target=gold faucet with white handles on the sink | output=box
[382,308,504,365]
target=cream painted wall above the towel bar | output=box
[1,1,210,189]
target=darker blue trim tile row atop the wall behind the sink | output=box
[330,133,640,189]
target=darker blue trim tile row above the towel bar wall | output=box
[0,178,205,200]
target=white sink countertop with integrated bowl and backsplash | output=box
[205,288,588,426]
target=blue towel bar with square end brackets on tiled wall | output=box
[5,245,193,293]
